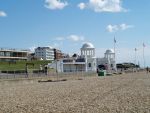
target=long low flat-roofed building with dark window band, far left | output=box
[0,48,29,61]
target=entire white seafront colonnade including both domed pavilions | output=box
[48,42,116,72]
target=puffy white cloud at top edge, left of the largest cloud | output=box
[45,0,68,10]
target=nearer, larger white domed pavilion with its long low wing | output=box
[49,43,97,72]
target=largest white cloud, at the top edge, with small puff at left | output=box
[78,0,127,12]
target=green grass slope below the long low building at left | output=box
[0,61,51,71]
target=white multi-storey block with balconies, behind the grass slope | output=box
[35,47,54,60]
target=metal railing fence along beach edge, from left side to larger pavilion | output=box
[0,70,96,79]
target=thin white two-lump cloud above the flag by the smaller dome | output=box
[106,24,133,32]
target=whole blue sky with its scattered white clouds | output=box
[0,0,150,66]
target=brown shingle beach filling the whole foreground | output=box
[0,72,150,113]
